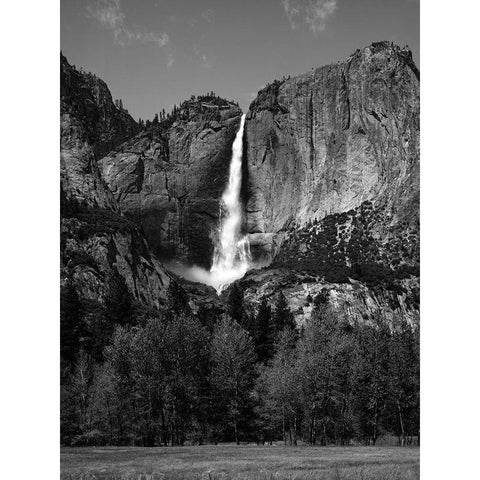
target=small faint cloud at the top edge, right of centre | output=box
[282,0,337,34]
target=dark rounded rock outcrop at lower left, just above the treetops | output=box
[61,209,170,309]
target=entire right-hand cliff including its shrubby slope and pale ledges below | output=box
[238,42,420,321]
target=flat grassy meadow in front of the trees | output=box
[61,445,420,480]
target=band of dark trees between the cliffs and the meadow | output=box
[61,277,419,446]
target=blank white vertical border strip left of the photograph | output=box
[0,0,60,479]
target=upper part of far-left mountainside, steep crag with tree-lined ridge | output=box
[60,55,139,209]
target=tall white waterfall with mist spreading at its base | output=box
[169,114,252,294]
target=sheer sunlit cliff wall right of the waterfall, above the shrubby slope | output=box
[245,42,420,266]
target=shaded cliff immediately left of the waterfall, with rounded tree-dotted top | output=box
[99,97,242,268]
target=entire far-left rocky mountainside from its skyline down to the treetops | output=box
[60,56,169,308]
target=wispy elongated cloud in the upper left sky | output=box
[87,0,173,53]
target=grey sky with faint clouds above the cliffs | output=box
[60,0,420,120]
